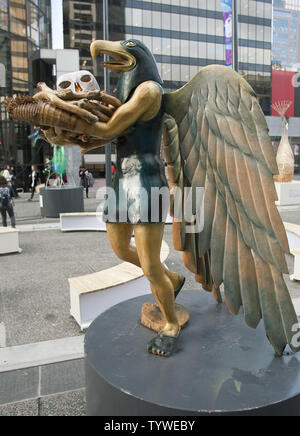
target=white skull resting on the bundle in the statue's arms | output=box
[57,70,100,92]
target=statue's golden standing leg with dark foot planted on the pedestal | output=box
[134,224,180,356]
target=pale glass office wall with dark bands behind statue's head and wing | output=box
[124,0,272,108]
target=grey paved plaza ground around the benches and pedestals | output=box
[0,177,300,416]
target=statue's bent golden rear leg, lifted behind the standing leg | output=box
[106,223,184,295]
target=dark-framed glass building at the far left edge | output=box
[0,0,51,166]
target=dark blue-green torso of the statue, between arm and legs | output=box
[104,85,168,224]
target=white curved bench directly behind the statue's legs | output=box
[69,242,169,330]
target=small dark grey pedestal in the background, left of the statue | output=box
[40,187,84,218]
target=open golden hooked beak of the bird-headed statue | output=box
[91,40,136,73]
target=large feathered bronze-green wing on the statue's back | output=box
[164,66,300,355]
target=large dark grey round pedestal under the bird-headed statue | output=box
[85,291,300,416]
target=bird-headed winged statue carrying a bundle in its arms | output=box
[7,39,300,356]
